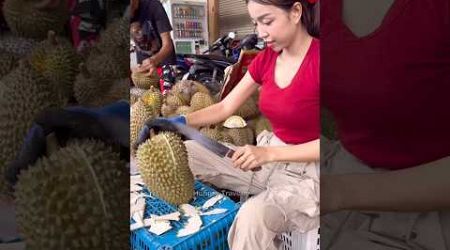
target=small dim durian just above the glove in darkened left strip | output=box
[74,63,113,106]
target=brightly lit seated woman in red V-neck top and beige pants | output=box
[141,0,320,249]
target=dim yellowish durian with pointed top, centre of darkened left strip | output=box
[28,31,81,99]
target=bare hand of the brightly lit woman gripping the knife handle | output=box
[231,145,271,171]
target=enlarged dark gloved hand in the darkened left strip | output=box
[5,101,130,186]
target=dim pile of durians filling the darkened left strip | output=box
[0,0,130,249]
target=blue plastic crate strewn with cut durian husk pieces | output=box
[130,181,239,250]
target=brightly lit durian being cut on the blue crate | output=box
[137,132,194,205]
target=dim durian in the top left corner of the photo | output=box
[3,0,70,39]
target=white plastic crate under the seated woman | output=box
[280,229,320,250]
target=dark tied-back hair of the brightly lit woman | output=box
[245,0,320,37]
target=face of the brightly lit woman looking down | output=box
[247,1,301,52]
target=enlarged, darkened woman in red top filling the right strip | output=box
[321,0,450,250]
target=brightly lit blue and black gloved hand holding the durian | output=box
[133,115,187,150]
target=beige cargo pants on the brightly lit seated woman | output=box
[185,131,320,250]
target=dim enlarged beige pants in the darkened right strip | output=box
[320,138,450,250]
